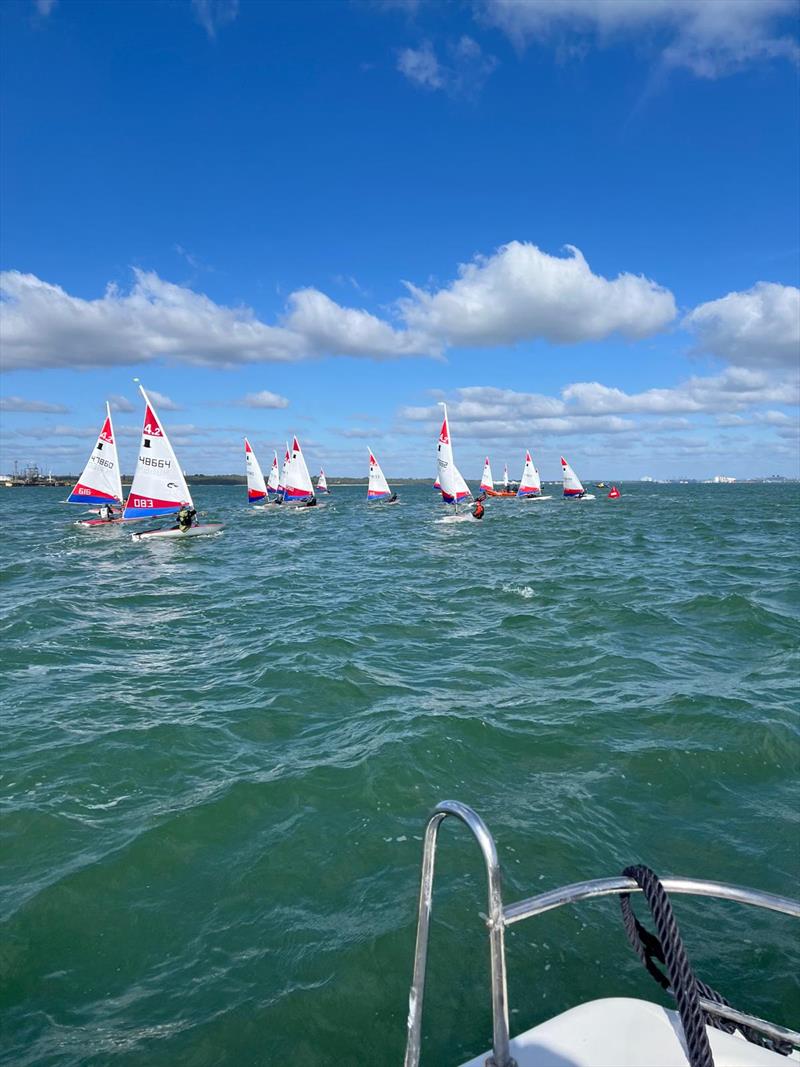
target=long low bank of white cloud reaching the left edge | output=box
[0,269,438,370]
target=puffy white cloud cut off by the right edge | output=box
[684,282,800,367]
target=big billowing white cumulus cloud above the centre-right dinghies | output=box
[400,241,676,346]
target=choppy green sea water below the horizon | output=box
[0,484,800,1067]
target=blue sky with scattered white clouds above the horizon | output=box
[0,0,800,478]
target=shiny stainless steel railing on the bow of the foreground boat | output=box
[404,800,800,1067]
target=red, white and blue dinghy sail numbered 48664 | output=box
[123,385,194,519]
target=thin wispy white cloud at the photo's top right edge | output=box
[479,0,800,78]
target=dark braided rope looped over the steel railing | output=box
[620,864,791,1067]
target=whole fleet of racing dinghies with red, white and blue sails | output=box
[70,385,621,540]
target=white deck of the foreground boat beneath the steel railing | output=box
[463,997,800,1067]
